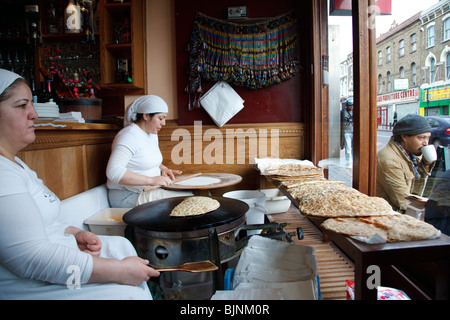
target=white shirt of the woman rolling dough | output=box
[106,123,163,193]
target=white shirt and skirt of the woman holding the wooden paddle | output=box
[0,156,151,300]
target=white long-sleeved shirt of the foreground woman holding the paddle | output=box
[0,156,93,297]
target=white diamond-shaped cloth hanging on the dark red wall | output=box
[200,81,244,127]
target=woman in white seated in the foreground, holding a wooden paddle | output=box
[0,69,159,300]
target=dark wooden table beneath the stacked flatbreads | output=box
[270,180,450,300]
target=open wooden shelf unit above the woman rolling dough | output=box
[99,0,145,94]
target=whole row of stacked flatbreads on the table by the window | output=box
[264,164,438,242]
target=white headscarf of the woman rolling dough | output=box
[123,95,169,127]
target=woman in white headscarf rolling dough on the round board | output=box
[106,95,192,208]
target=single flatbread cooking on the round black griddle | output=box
[170,196,220,217]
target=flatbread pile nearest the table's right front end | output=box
[322,214,438,242]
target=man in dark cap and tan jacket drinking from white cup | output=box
[377,114,434,213]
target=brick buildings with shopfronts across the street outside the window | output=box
[341,0,450,127]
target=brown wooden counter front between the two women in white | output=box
[18,121,119,200]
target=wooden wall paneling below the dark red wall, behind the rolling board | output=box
[158,123,304,195]
